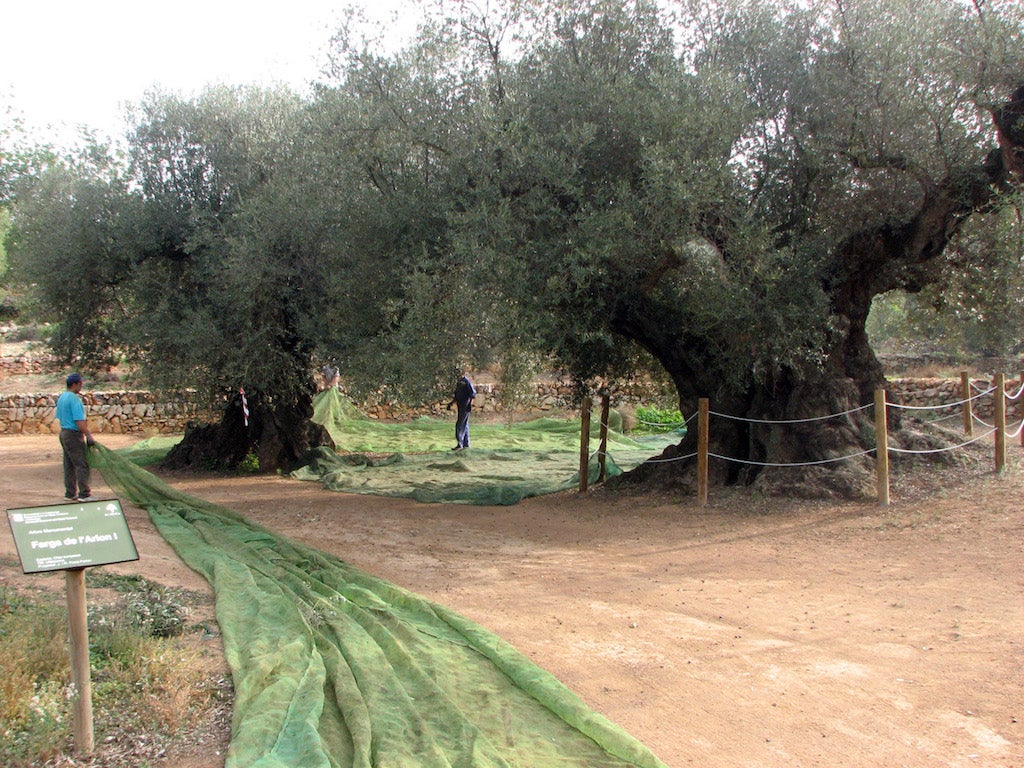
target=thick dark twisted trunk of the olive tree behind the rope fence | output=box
[615,86,1024,498]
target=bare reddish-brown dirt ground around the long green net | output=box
[0,436,1024,768]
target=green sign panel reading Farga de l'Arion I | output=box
[7,499,138,573]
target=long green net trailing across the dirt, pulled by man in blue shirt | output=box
[91,445,663,768]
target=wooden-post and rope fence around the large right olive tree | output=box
[580,372,1024,506]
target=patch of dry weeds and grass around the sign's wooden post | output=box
[0,570,232,768]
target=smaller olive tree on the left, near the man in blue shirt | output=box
[12,87,395,469]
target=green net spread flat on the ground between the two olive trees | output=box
[292,388,681,504]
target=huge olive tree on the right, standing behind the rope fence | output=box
[333,0,1024,494]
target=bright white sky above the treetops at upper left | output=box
[0,0,411,145]
